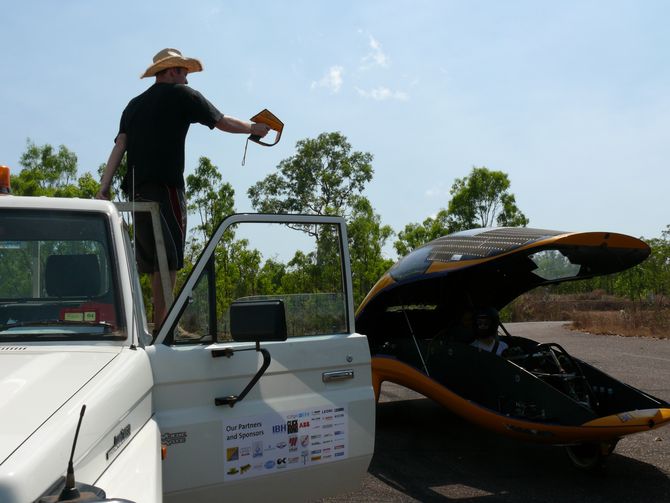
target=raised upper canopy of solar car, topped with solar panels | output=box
[356,227,651,334]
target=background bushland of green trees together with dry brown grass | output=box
[6,136,670,338]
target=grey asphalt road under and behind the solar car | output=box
[322,322,670,503]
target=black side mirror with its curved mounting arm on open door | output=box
[212,300,286,407]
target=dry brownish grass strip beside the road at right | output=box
[510,289,670,339]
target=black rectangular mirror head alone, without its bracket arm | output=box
[230,299,286,342]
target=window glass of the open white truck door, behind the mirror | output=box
[174,222,347,343]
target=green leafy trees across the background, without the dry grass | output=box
[14,137,670,330]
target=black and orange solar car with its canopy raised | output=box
[356,228,670,468]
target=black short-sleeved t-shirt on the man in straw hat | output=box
[119,83,223,194]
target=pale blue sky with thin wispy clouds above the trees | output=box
[0,0,670,260]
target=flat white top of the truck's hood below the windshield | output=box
[0,348,118,464]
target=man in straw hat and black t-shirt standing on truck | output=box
[96,48,270,328]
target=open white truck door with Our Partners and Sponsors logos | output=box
[147,215,375,502]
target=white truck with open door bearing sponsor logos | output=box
[0,195,375,503]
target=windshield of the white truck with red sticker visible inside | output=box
[0,209,125,342]
